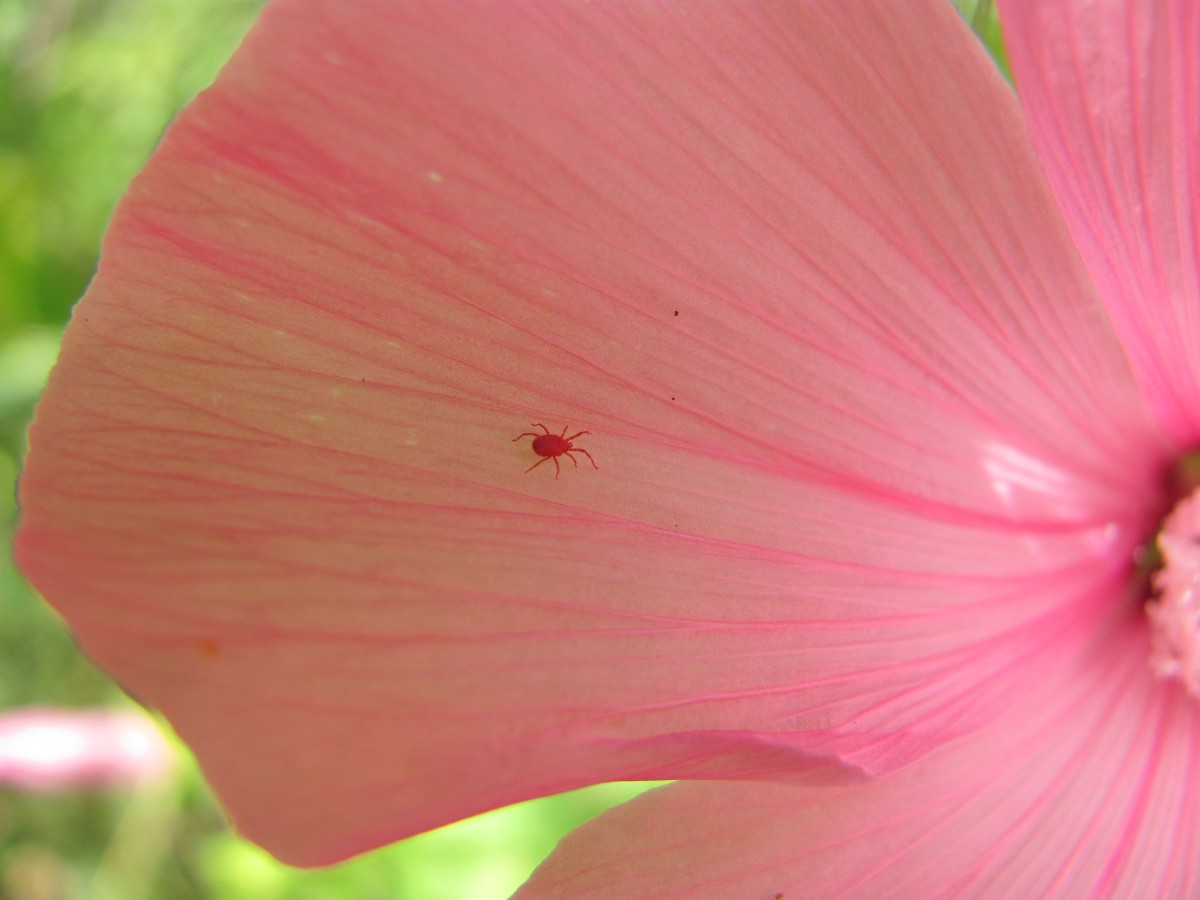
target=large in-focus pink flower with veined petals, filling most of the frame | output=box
[18,0,1200,898]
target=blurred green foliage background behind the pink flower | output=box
[0,0,998,900]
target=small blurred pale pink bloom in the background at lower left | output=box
[0,707,174,791]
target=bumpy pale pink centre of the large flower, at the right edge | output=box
[1146,490,1200,698]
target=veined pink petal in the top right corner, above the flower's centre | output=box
[1001,0,1200,444]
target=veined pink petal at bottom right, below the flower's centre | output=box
[517,617,1200,899]
